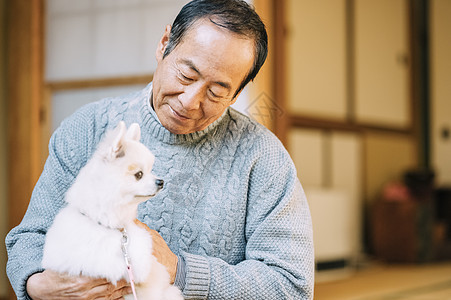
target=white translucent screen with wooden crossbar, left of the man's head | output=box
[45,0,188,131]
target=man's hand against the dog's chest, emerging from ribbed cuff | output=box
[135,219,178,284]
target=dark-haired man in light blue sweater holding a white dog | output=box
[6,0,314,300]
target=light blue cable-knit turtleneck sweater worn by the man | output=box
[6,84,314,300]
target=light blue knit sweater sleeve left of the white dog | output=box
[5,107,96,299]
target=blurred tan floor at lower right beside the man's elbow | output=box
[315,262,451,300]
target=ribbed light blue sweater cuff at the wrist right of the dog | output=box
[182,252,210,299]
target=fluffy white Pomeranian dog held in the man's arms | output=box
[42,121,183,300]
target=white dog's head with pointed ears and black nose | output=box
[100,122,163,204]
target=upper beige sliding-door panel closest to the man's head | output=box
[286,0,347,121]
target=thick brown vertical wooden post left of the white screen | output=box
[7,0,44,228]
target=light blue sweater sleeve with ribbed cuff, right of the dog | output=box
[179,138,314,300]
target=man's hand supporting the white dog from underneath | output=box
[27,270,132,300]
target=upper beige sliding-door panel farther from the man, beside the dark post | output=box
[354,0,412,128]
